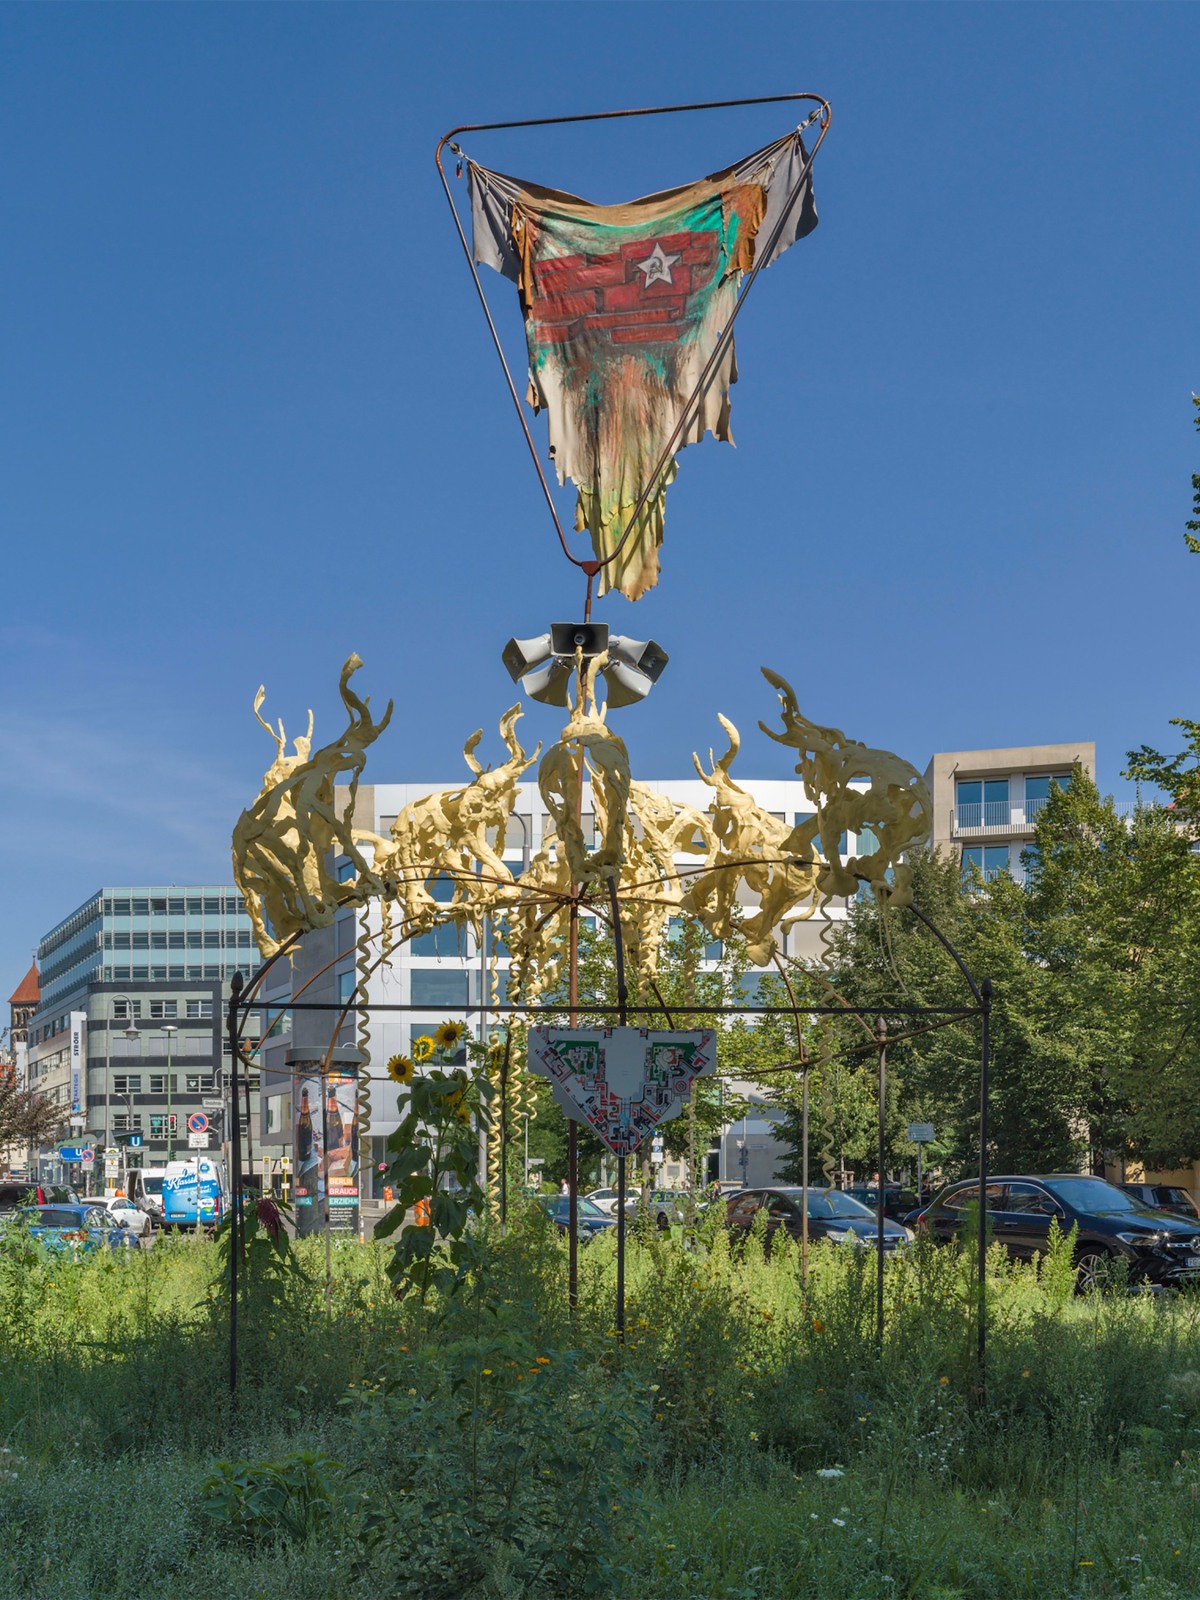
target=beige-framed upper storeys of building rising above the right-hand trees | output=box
[925,741,1096,882]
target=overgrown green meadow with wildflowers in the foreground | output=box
[0,1211,1200,1600]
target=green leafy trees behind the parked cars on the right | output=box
[752,770,1200,1181]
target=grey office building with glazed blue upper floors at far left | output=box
[27,883,258,1187]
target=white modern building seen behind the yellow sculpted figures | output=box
[258,778,866,1181]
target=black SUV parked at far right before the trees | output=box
[920,1173,1200,1290]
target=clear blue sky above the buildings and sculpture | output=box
[0,3,1200,994]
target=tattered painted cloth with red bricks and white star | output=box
[467,133,816,600]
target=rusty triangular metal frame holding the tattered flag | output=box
[434,90,832,621]
